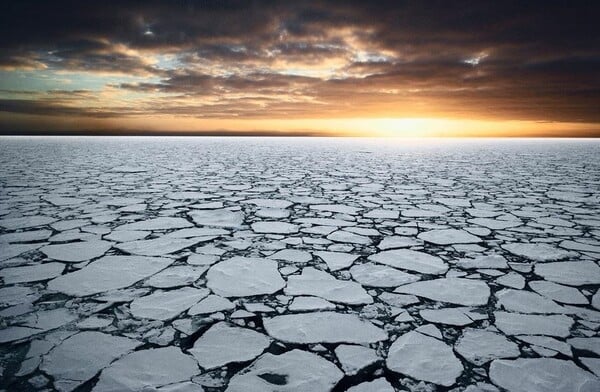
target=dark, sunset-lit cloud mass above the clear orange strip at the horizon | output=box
[0,1,600,122]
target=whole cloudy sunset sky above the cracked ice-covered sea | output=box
[0,0,600,137]
